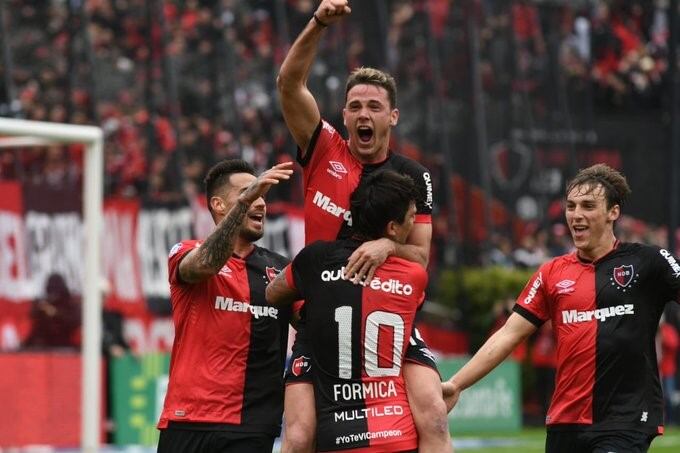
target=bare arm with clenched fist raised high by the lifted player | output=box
[276,0,351,156]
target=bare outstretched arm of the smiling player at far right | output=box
[442,313,537,412]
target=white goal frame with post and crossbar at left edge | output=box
[0,118,104,453]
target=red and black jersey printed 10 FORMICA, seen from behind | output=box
[285,240,427,452]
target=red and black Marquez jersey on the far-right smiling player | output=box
[514,243,680,433]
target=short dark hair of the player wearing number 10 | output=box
[350,170,418,239]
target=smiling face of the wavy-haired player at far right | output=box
[566,184,619,259]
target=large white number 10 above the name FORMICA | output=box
[335,306,405,379]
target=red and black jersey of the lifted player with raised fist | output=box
[297,120,433,244]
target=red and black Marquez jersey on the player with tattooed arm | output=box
[158,240,290,435]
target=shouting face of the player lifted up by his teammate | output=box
[342,85,399,163]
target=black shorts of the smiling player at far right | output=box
[545,430,656,453]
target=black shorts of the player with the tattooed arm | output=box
[157,426,274,453]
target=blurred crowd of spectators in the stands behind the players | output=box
[0,0,668,258]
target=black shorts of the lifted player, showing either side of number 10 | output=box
[285,328,441,384]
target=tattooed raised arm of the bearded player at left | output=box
[179,162,293,283]
